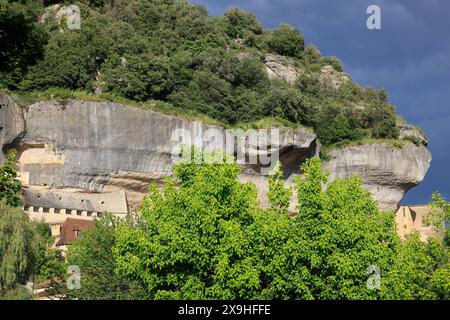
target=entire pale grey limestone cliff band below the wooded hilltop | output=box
[0,94,431,209]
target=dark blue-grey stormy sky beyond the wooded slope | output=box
[190,0,450,204]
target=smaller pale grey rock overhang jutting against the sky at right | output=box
[324,142,431,210]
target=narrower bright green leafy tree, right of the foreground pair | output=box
[287,159,398,299]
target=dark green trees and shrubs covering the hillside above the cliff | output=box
[0,0,399,145]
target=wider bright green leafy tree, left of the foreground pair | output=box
[115,150,296,299]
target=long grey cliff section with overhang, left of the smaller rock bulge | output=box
[0,95,318,207]
